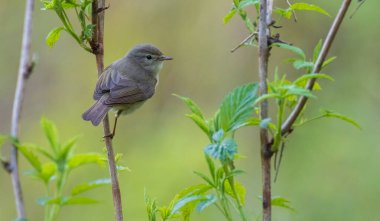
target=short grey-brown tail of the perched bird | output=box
[82,96,111,126]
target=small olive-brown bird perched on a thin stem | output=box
[82,44,172,137]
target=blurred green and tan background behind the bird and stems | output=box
[0,0,380,221]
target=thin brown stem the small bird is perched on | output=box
[91,0,123,221]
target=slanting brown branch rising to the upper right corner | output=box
[281,0,351,135]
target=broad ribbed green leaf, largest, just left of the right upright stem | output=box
[218,83,258,133]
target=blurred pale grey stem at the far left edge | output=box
[8,0,34,219]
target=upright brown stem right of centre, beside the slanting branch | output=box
[258,0,273,221]
